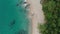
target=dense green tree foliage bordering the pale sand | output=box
[39,0,60,34]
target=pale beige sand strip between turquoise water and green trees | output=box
[27,0,44,34]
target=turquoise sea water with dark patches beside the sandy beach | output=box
[0,0,29,34]
